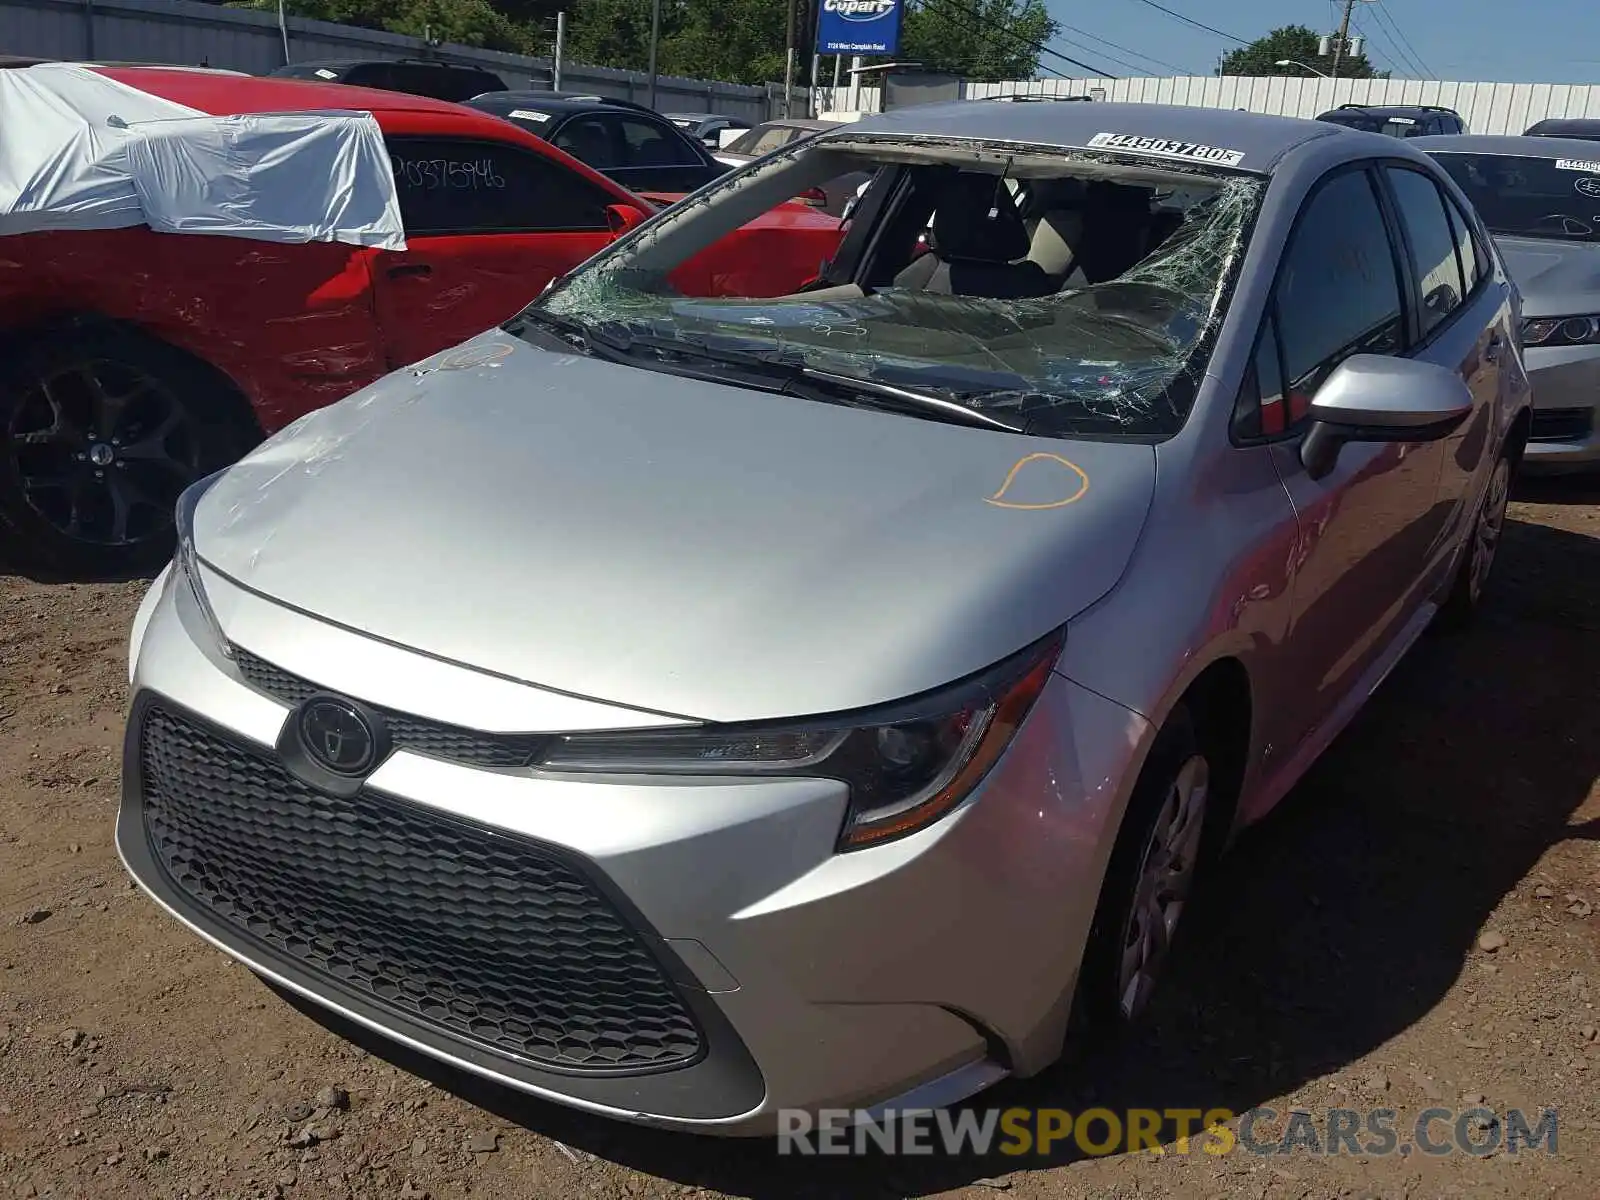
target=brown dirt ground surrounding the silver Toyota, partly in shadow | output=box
[0,485,1600,1200]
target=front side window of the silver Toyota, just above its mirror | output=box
[1274,170,1403,410]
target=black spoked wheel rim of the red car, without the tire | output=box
[6,358,200,546]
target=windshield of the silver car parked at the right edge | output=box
[1434,149,1600,242]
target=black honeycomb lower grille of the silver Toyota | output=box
[139,706,702,1072]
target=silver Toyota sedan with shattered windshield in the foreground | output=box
[118,102,1528,1133]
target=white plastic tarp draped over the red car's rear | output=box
[0,62,405,250]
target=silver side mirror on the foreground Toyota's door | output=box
[1301,354,1472,478]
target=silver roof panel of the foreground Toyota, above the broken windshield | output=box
[822,101,1350,171]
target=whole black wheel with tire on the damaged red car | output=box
[0,323,259,579]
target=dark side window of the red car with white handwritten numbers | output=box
[389,138,611,237]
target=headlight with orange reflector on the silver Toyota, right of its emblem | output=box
[539,632,1064,850]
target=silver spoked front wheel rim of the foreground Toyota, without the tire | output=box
[1117,754,1211,1021]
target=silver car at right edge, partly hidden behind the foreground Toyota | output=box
[1416,136,1600,472]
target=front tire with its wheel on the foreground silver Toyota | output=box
[1074,704,1214,1035]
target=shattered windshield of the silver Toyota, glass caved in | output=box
[507,139,1266,437]
